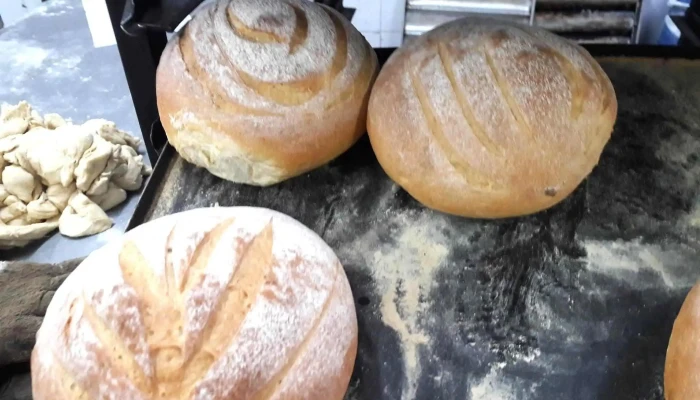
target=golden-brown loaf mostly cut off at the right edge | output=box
[664,283,700,400]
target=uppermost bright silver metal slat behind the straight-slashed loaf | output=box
[406,0,531,16]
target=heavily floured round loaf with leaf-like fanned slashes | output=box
[31,207,357,400]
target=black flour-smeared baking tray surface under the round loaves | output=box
[134,58,700,400]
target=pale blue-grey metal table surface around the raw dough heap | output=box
[0,0,148,263]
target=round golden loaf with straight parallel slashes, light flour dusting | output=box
[368,18,617,218]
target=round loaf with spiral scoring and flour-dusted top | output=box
[156,0,377,186]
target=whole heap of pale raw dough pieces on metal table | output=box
[0,101,151,249]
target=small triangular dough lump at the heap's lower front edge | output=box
[58,192,112,237]
